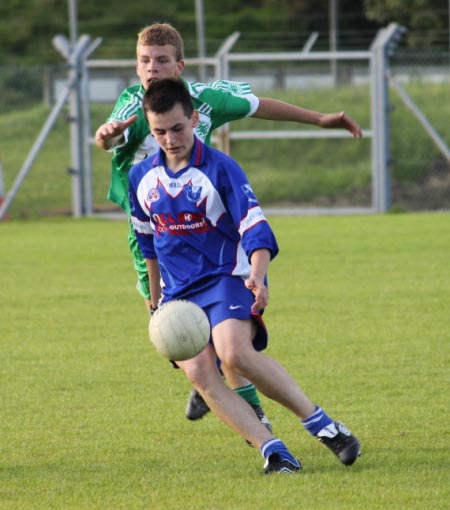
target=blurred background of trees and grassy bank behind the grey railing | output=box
[0,0,450,218]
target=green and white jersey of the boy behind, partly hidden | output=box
[107,80,259,213]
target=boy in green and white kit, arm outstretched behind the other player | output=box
[95,23,362,429]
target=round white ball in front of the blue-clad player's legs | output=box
[148,300,210,361]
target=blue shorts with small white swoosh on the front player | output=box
[163,275,269,351]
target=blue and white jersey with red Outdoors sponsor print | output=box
[129,138,278,299]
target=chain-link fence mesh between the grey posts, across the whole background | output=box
[0,48,450,217]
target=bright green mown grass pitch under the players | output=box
[0,214,450,510]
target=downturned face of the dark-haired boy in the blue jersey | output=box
[147,104,198,172]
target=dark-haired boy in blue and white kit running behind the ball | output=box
[129,79,360,473]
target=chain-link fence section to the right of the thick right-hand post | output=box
[390,50,450,210]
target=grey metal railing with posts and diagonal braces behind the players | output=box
[0,24,450,218]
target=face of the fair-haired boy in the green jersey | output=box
[136,44,184,90]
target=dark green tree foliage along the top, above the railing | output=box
[0,0,448,64]
